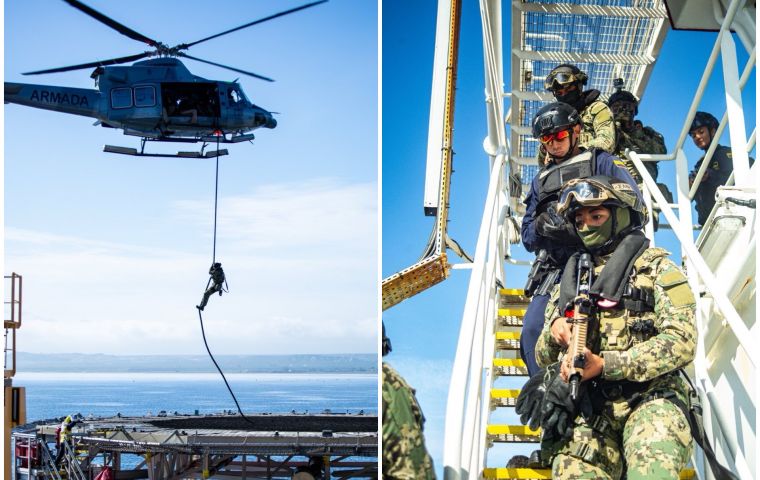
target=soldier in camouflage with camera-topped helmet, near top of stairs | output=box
[607,90,667,184]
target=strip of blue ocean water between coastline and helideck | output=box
[13,373,378,422]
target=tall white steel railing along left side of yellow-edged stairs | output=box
[443,0,510,480]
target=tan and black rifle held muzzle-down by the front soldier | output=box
[567,253,594,400]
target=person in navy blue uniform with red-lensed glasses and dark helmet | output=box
[520,102,640,375]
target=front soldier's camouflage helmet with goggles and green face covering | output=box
[557,175,647,254]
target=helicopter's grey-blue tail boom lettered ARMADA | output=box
[5,82,101,118]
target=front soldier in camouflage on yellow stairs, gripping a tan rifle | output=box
[517,176,696,480]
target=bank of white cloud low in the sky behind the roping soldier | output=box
[5,180,377,354]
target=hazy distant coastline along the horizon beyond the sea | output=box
[16,352,377,374]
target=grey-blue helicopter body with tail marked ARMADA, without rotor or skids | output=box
[5,58,277,139]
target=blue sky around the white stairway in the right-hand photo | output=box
[382,0,756,474]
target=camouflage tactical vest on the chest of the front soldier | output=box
[592,248,668,351]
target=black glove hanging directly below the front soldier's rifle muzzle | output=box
[541,364,593,440]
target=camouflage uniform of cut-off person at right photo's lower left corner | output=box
[383,363,435,480]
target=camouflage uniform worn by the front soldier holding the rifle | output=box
[536,248,697,480]
